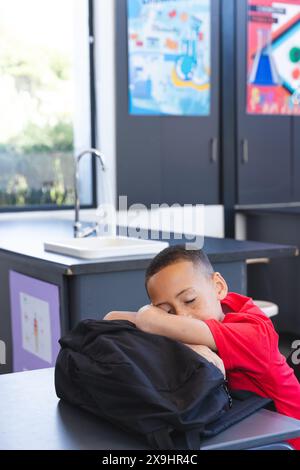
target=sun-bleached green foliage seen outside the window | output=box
[0,7,74,207]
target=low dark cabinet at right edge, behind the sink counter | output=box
[244,207,300,338]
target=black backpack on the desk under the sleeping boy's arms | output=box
[55,320,270,449]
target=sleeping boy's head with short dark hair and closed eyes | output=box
[145,245,228,320]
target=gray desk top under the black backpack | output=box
[0,369,300,450]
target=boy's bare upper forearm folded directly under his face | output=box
[135,305,217,351]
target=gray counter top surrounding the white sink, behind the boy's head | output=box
[0,216,298,276]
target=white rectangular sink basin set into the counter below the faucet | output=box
[44,236,169,259]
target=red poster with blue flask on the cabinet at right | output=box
[247,0,300,116]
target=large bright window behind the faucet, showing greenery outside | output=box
[0,0,93,210]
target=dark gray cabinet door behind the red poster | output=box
[236,0,292,204]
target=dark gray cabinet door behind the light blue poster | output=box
[116,0,220,206]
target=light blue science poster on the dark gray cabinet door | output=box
[127,0,211,116]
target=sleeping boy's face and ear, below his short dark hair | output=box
[147,261,228,321]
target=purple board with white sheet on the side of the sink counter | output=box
[9,271,61,372]
